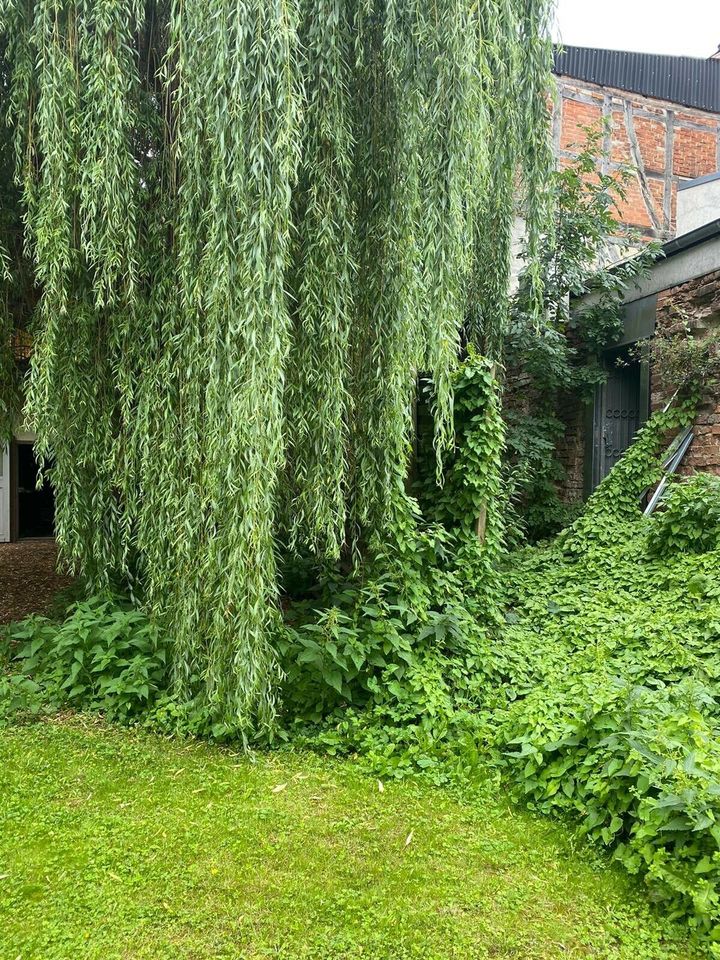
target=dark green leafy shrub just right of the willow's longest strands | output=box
[279,526,497,781]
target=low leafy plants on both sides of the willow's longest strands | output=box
[5,402,720,944]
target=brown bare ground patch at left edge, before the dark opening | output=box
[0,540,71,623]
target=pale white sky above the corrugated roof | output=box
[555,0,720,57]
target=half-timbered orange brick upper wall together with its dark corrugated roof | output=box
[551,47,720,240]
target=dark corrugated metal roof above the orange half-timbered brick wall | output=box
[554,47,720,113]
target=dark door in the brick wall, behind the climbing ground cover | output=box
[592,346,648,488]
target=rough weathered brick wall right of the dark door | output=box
[650,270,720,474]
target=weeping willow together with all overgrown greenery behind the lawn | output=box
[5,0,720,957]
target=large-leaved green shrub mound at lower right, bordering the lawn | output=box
[500,671,720,936]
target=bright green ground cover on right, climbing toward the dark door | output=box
[489,409,720,941]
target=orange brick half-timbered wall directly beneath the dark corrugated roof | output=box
[552,77,720,240]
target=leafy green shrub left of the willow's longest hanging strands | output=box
[0,596,168,722]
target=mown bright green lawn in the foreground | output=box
[0,721,696,960]
